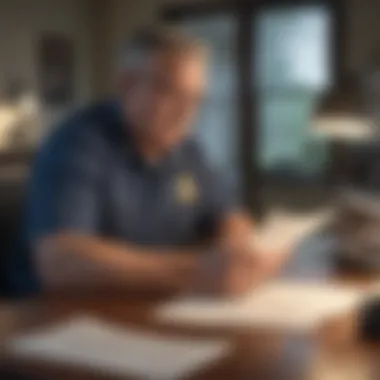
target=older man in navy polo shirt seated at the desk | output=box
[12,29,286,294]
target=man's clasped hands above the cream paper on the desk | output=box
[190,213,289,296]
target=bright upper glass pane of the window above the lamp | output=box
[255,7,331,89]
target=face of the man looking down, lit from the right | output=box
[124,52,206,150]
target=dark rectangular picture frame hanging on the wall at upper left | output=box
[38,33,74,106]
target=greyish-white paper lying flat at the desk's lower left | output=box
[9,317,229,380]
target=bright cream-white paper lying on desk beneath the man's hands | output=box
[157,282,363,332]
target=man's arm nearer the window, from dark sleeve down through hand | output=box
[198,154,290,294]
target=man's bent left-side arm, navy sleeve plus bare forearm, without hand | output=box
[27,126,203,290]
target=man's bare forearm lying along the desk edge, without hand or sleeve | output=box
[35,232,199,291]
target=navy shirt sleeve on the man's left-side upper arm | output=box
[26,126,104,241]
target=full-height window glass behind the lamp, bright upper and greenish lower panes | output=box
[253,6,331,175]
